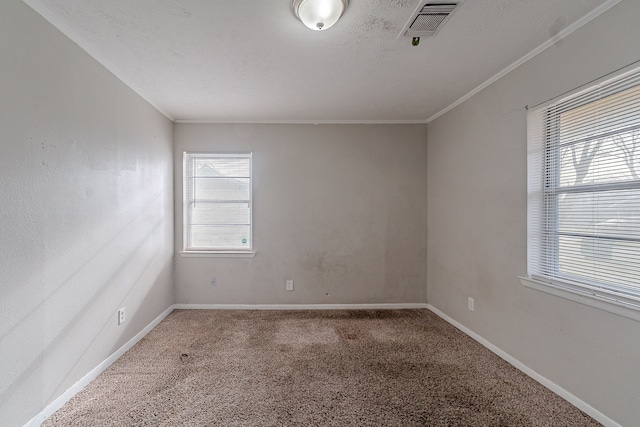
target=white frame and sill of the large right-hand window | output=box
[520,64,640,320]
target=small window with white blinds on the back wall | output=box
[183,153,253,253]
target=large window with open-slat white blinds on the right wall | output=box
[528,67,640,309]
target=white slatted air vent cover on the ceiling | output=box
[398,0,462,37]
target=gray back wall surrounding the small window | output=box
[175,124,427,304]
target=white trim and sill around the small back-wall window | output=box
[178,151,256,258]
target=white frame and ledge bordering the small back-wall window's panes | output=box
[179,151,256,258]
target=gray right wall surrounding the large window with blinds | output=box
[427,1,640,426]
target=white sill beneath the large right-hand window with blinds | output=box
[518,277,640,321]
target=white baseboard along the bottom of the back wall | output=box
[173,303,427,310]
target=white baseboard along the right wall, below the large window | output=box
[427,304,622,427]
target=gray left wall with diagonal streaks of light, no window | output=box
[0,0,173,426]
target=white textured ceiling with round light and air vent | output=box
[24,0,618,123]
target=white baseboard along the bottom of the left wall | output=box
[24,306,174,427]
